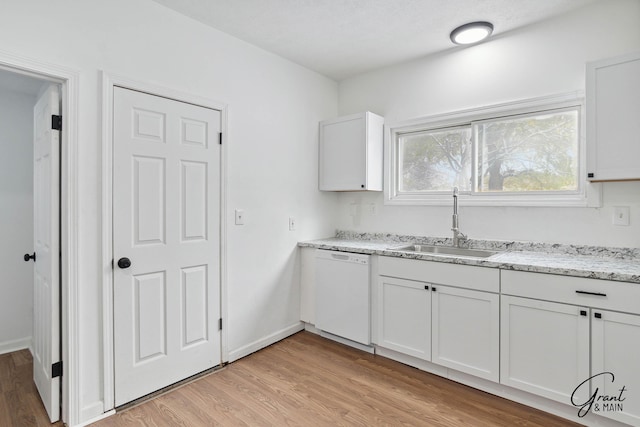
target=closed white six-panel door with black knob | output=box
[113,87,221,406]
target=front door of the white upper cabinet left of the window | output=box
[320,114,367,191]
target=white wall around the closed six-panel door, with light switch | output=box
[0,0,338,419]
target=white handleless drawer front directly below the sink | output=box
[378,256,500,293]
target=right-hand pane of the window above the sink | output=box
[475,110,578,191]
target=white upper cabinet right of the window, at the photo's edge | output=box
[587,52,640,181]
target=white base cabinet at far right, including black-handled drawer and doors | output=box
[500,270,640,425]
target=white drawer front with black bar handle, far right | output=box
[500,270,640,314]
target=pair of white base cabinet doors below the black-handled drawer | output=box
[500,295,640,426]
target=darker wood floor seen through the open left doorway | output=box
[0,350,62,427]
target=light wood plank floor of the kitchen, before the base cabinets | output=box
[92,332,578,427]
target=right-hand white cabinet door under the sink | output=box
[431,285,500,382]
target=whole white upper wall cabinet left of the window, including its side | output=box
[319,112,384,191]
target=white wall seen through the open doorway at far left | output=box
[0,88,36,353]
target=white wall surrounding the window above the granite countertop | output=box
[338,0,640,247]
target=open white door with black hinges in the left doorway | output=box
[32,85,60,422]
